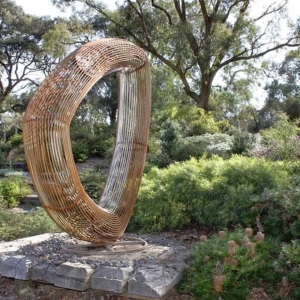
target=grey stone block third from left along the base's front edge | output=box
[54,262,94,291]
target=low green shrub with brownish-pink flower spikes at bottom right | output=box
[179,230,300,300]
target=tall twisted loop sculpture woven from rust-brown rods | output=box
[23,39,151,245]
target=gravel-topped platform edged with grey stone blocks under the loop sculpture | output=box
[0,233,189,299]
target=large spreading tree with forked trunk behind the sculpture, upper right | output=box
[52,0,298,110]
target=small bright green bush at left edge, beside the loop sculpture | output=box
[0,176,32,208]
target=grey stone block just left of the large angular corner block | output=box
[91,266,133,294]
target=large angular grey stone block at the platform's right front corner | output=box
[128,262,186,298]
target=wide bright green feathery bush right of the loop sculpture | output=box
[129,156,300,238]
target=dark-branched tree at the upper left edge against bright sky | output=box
[0,0,61,109]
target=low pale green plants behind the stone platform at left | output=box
[0,208,60,241]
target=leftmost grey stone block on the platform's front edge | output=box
[1,255,32,280]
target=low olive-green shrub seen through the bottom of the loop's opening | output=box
[79,167,106,203]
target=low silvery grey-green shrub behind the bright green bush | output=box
[173,133,232,161]
